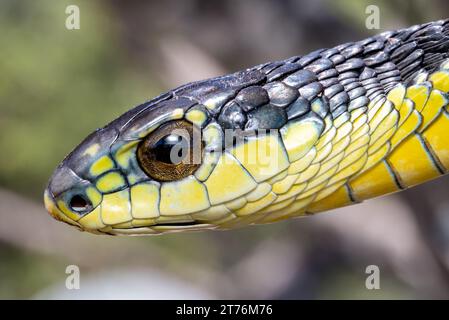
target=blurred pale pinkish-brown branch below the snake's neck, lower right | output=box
[286,196,449,298]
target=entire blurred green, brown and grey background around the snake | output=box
[0,0,449,299]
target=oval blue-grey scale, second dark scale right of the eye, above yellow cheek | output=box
[245,104,287,130]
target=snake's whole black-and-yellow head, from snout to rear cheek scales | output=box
[45,69,323,235]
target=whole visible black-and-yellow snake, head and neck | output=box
[44,19,449,235]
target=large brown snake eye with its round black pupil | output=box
[137,120,203,181]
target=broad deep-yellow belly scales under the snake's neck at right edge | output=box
[308,64,449,211]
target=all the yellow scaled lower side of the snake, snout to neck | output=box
[79,62,449,233]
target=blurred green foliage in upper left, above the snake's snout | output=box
[0,0,157,196]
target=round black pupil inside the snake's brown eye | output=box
[152,134,188,164]
